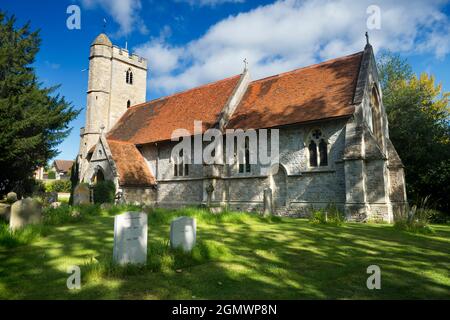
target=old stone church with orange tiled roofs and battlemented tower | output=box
[78,34,406,222]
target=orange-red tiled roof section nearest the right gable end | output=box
[227,52,363,129]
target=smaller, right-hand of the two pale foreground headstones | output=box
[170,217,197,252]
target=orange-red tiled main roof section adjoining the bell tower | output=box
[108,75,241,144]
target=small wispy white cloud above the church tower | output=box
[81,0,148,36]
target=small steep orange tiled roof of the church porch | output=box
[108,139,155,186]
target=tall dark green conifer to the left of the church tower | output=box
[0,11,79,196]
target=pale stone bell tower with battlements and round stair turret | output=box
[78,33,147,178]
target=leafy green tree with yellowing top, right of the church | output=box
[378,53,450,213]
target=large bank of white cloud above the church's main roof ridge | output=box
[137,0,450,94]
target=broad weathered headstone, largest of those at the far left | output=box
[9,198,42,230]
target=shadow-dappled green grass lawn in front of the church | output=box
[0,205,450,299]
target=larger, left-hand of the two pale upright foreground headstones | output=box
[113,212,148,265]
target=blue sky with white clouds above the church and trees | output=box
[0,0,450,159]
